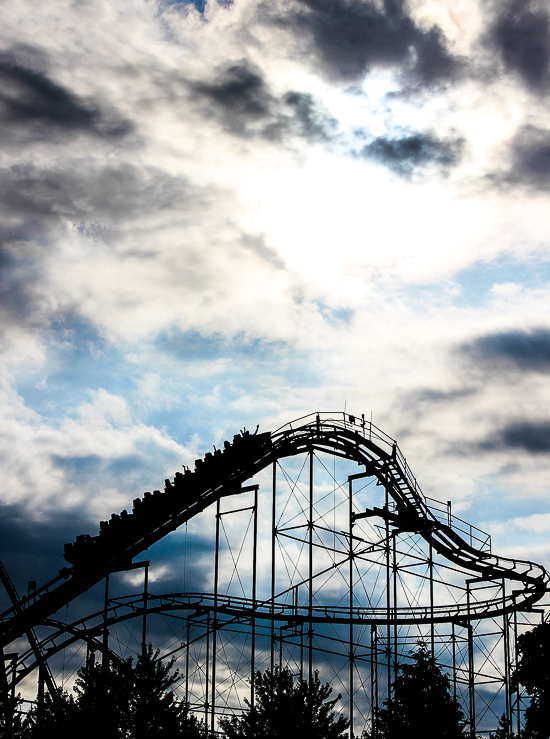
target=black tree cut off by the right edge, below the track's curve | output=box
[512,621,550,739]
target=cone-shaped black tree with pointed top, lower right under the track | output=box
[370,643,466,739]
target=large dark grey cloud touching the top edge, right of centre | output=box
[264,0,459,84]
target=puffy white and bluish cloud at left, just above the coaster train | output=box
[0,388,191,521]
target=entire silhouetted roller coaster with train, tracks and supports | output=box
[0,413,550,739]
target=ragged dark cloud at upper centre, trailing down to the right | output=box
[191,62,336,141]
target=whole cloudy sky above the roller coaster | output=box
[0,0,550,660]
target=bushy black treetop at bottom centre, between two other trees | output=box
[220,667,349,739]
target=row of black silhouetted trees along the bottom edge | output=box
[0,622,550,739]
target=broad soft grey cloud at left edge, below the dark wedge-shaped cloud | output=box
[0,156,203,340]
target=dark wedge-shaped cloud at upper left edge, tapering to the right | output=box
[0,54,132,142]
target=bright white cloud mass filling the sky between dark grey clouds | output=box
[0,0,550,632]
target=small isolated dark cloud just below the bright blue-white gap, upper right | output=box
[361,133,463,177]
